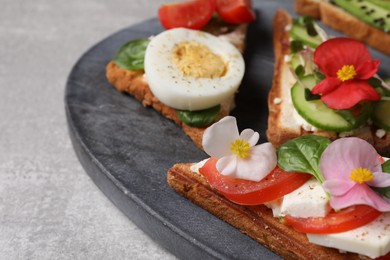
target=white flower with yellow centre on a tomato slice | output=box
[202,116,277,181]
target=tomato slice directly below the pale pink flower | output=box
[284,205,381,234]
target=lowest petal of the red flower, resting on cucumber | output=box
[321,80,381,109]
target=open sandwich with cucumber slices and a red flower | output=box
[267,10,390,156]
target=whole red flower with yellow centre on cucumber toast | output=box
[312,38,381,109]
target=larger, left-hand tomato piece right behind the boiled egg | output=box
[158,0,216,30]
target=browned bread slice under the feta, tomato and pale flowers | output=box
[167,163,364,260]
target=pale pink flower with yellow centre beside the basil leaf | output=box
[320,137,390,212]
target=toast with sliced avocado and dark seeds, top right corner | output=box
[295,0,390,55]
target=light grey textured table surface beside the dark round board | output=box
[0,0,175,259]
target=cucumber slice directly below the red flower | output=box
[291,75,360,132]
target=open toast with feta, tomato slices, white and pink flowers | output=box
[168,116,390,259]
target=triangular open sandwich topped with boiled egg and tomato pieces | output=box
[106,0,255,148]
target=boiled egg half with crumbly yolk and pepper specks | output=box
[144,28,245,111]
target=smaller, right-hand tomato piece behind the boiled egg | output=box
[217,0,256,24]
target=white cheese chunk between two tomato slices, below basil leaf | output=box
[280,178,330,218]
